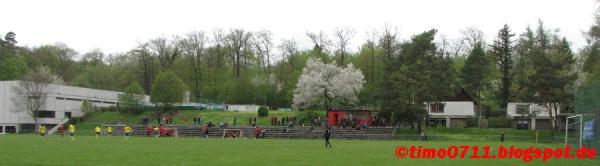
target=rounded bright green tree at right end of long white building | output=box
[150,70,187,109]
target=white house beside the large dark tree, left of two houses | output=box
[426,90,476,127]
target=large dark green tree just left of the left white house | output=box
[381,29,453,133]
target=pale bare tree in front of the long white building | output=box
[12,66,63,130]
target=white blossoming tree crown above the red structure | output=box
[293,59,365,111]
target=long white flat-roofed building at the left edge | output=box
[0,81,122,133]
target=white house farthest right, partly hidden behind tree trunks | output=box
[506,103,560,130]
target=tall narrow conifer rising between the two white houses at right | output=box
[491,24,515,108]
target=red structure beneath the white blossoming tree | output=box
[327,109,373,126]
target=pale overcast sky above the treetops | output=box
[0,0,598,56]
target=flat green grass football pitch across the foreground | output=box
[0,135,600,166]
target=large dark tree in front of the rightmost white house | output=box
[520,21,577,134]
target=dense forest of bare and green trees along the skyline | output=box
[0,8,600,120]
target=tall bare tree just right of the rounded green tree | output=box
[181,32,208,97]
